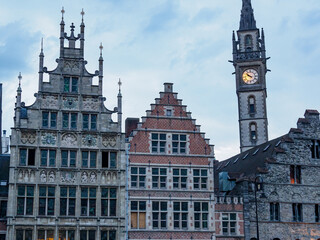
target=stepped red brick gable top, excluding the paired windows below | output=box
[129,83,214,155]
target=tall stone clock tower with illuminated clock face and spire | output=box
[232,0,268,152]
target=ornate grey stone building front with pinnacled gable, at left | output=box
[7,11,125,240]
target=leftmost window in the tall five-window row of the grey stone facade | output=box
[17,186,34,215]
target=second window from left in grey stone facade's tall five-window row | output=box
[39,187,55,216]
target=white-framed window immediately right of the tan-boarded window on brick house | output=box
[152,201,168,229]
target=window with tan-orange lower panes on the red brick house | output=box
[131,201,146,229]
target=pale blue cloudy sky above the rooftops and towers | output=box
[0,0,320,160]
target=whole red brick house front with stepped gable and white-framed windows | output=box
[128,83,215,240]
